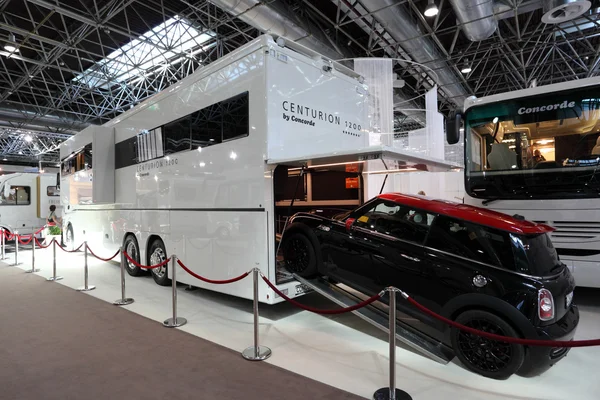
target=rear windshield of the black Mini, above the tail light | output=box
[511,233,562,276]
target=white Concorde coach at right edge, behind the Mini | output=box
[447,77,600,287]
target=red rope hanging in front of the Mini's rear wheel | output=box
[406,297,600,347]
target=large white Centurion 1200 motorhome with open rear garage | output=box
[61,35,449,303]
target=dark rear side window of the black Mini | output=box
[427,216,515,270]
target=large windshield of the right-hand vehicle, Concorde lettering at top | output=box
[465,86,600,199]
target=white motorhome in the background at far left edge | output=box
[0,172,60,234]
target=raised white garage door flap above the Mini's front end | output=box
[267,145,461,173]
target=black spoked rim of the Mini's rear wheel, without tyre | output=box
[458,319,513,372]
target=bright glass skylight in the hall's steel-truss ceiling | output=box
[73,15,216,90]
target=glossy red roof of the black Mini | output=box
[377,193,554,235]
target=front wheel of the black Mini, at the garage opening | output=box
[281,232,318,278]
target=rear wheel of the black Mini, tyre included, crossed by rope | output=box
[451,310,525,379]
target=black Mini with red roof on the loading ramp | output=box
[282,193,579,379]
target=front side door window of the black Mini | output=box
[355,201,434,243]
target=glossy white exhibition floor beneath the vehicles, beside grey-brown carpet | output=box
[2,244,600,400]
